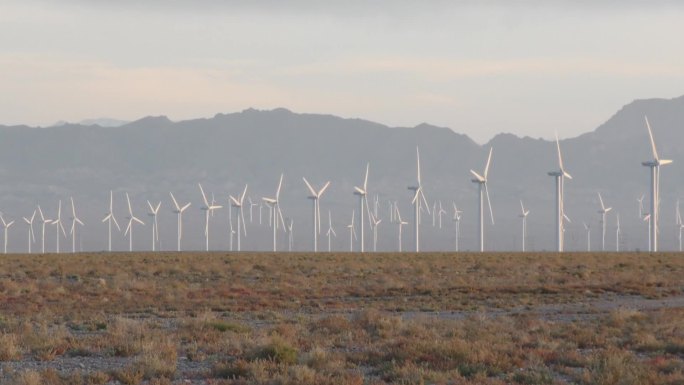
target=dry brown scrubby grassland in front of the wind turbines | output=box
[0,253,684,384]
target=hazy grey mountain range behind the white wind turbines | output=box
[0,97,684,250]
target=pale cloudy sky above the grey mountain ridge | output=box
[0,0,684,142]
